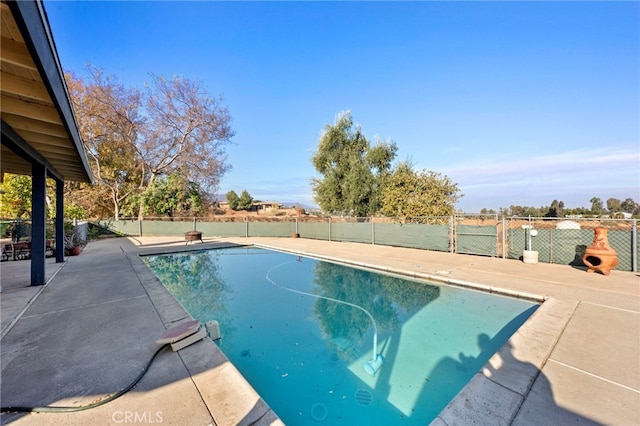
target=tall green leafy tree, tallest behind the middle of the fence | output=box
[311,111,397,216]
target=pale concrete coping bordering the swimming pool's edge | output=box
[136,242,564,426]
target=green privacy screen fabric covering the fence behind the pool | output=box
[100,220,635,271]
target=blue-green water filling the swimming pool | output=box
[145,247,538,425]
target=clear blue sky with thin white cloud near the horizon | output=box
[45,0,640,212]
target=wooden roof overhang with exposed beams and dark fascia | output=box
[0,0,93,183]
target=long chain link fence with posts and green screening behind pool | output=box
[103,214,637,271]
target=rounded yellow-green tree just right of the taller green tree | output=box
[381,162,462,219]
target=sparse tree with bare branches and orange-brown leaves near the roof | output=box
[67,66,234,219]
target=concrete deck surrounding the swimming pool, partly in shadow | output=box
[0,237,640,425]
